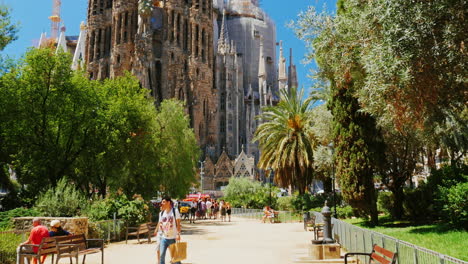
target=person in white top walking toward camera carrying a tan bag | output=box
[157,196,182,264]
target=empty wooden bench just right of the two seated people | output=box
[52,234,104,264]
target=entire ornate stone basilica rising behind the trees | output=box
[39,0,298,190]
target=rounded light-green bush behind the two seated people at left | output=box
[36,178,88,217]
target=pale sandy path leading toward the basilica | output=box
[68,217,312,264]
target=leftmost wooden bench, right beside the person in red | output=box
[18,237,57,264]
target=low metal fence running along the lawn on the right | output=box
[314,212,468,264]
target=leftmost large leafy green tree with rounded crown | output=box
[0,49,94,193]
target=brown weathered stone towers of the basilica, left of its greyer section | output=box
[86,0,218,152]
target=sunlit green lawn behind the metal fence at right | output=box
[344,217,468,261]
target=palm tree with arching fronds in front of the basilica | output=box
[254,88,316,194]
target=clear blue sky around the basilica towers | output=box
[0,0,336,92]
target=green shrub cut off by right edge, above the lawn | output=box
[440,182,468,229]
